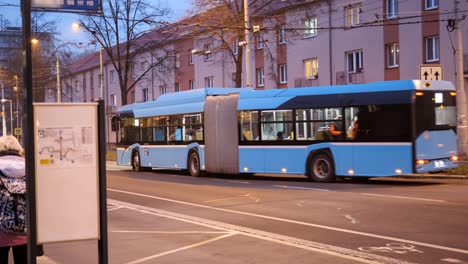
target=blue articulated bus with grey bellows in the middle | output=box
[117,80,458,182]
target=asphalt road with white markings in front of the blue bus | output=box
[39,167,468,264]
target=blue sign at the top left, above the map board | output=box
[31,0,101,13]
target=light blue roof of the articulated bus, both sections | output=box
[117,80,455,117]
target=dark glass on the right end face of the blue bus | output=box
[416,91,457,135]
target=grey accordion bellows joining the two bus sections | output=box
[204,94,239,174]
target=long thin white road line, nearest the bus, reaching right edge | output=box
[107,188,468,255]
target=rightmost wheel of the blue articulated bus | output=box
[309,154,335,182]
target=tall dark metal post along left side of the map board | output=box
[21,0,37,264]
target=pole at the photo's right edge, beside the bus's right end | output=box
[454,0,468,156]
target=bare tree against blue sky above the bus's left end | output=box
[80,0,169,105]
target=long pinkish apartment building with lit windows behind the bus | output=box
[62,0,468,146]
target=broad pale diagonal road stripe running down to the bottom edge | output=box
[108,199,409,264]
